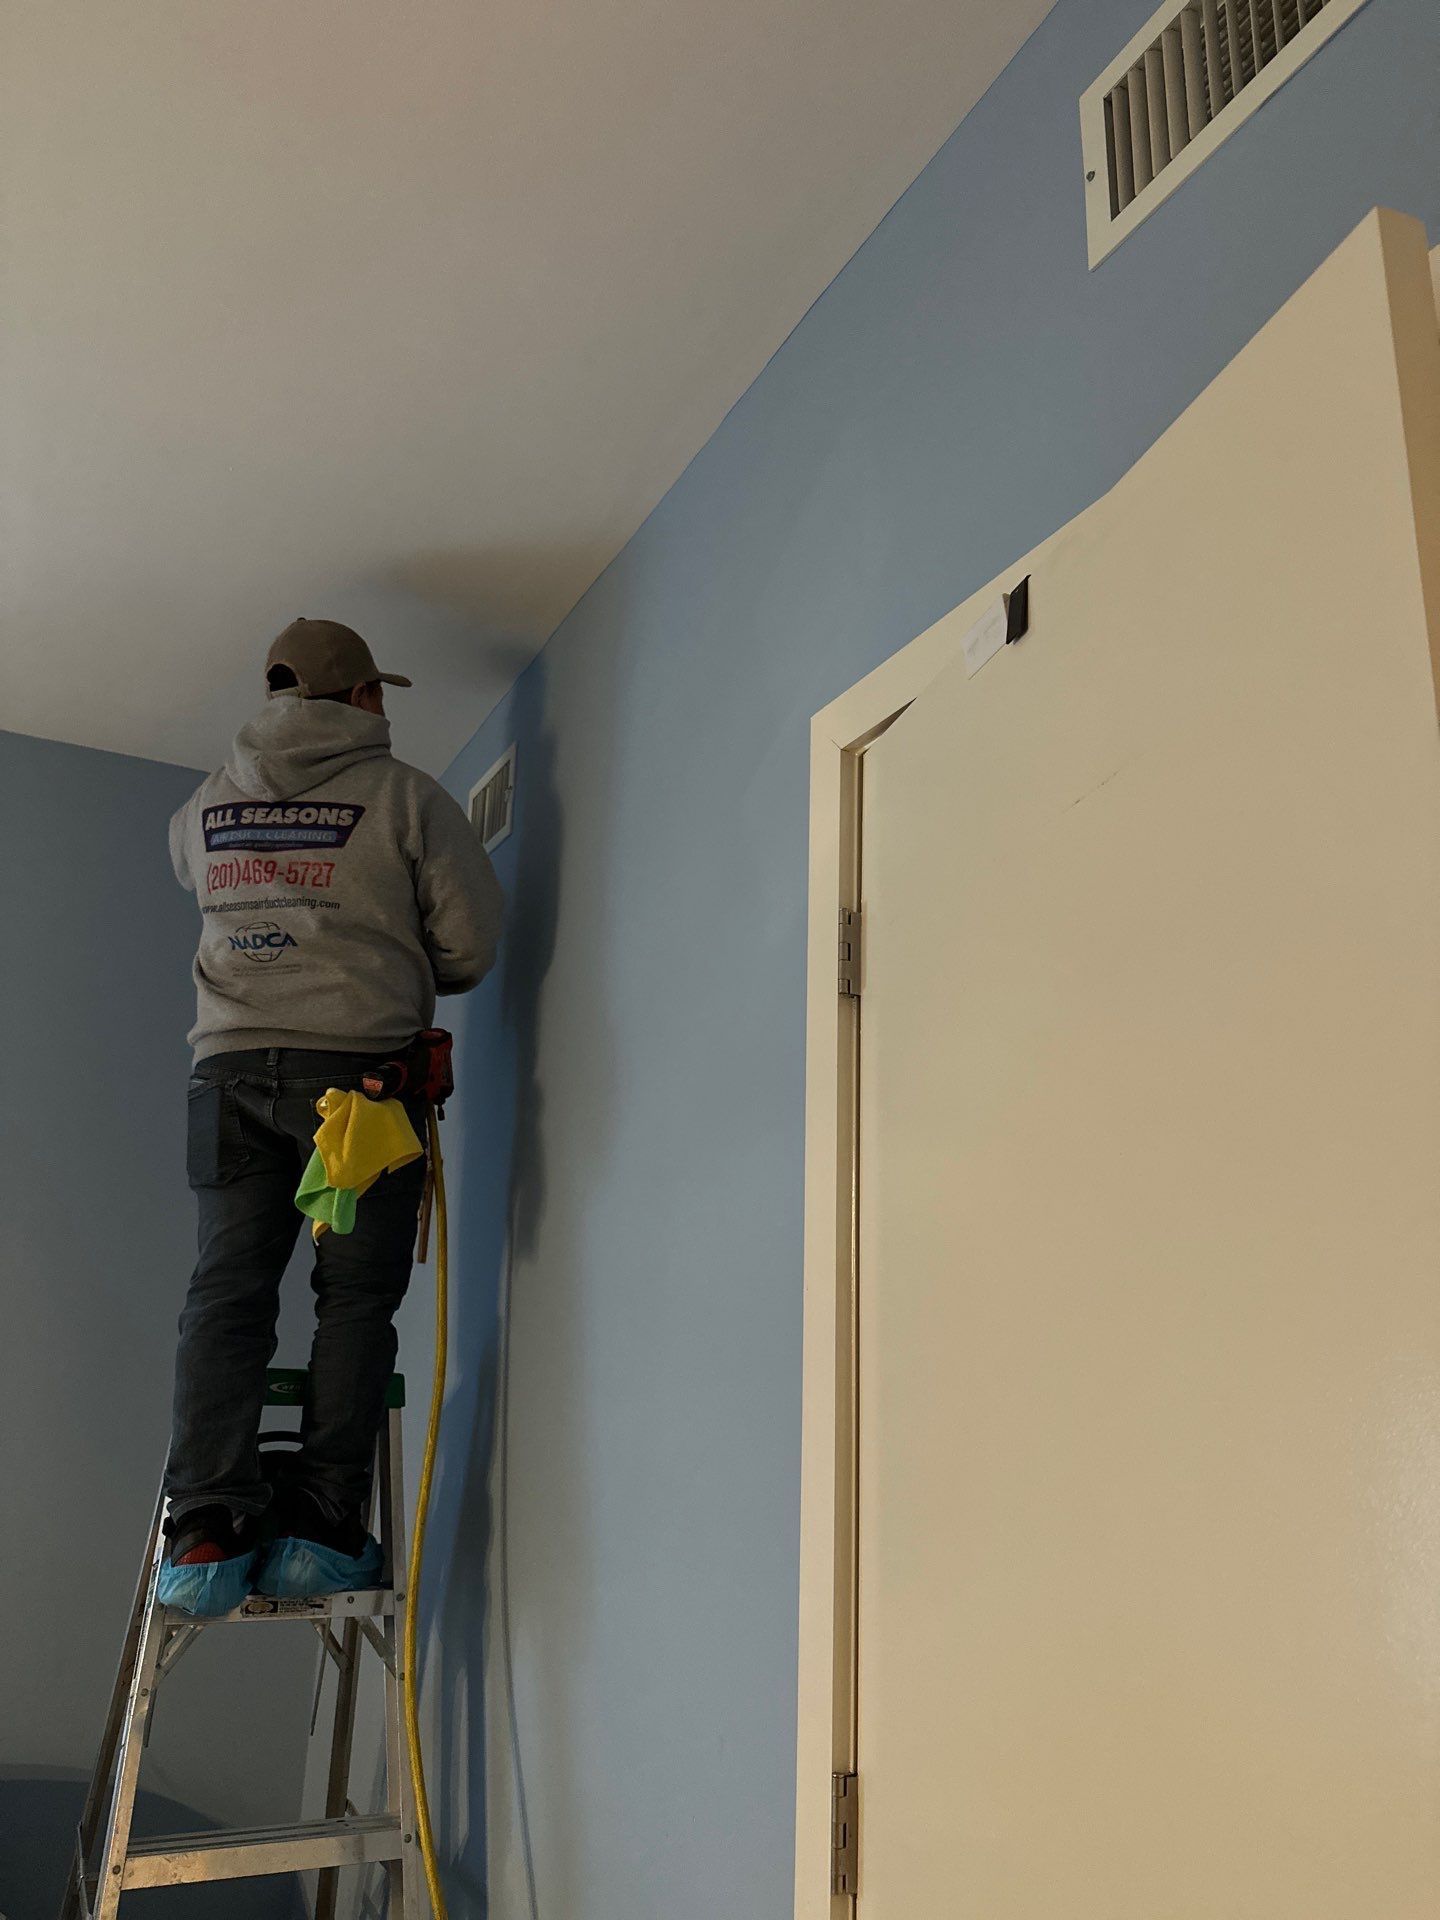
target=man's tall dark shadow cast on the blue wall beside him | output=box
[385,622,622,1920]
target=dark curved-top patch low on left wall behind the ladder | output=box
[0,1768,305,1920]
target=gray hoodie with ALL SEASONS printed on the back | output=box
[171,693,501,1060]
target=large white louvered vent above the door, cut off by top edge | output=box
[1081,0,1365,267]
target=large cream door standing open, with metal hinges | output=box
[856,202,1440,1920]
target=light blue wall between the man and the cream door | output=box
[411,0,1440,1920]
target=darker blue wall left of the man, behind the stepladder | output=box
[0,733,313,1920]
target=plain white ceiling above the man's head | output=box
[0,0,1050,768]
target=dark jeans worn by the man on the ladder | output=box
[165,1046,424,1519]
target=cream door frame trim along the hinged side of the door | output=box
[795,211,1440,1920]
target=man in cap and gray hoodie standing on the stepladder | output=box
[156,620,501,1619]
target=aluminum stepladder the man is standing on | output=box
[60,1367,430,1920]
